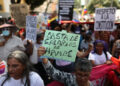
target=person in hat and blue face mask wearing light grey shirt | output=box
[0,24,25,61]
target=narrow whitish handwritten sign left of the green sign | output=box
[26,16,37,43]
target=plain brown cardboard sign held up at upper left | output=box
[10,4,29,28]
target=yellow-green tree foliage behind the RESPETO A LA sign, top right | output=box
[87,0,120,13]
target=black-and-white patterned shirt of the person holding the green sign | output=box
[43,61,93,86]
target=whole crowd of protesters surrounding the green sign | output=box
[0,11,120,86]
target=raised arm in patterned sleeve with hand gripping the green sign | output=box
[38,47,74,83]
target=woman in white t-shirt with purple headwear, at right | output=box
[88,40,112,66]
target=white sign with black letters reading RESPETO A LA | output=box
[94,7,116,31]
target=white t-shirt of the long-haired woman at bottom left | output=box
[0,72,44,86]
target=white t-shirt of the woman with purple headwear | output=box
[88,52,112,65]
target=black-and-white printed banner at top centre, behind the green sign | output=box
[58,0,74,21]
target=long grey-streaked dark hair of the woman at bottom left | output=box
[1,50,33,86]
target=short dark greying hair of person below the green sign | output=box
[75,58,92,72]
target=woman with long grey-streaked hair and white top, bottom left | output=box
[0,50,44,86]
